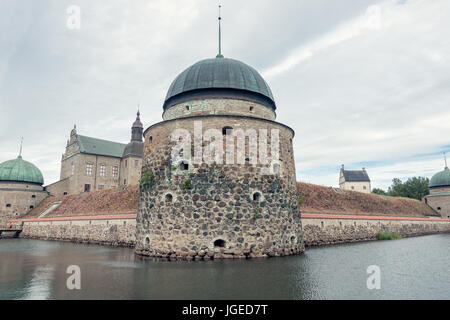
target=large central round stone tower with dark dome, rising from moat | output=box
[136,55,304,260]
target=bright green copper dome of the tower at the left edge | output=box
[0,156,44,185]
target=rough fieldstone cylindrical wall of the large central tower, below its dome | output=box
[136,116,304,260]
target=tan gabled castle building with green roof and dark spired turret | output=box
[46,112,144,196]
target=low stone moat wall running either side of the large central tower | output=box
[13,214,450,252]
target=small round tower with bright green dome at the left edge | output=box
[0,155,48,224]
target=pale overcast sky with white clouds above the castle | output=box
[0,0,450,188]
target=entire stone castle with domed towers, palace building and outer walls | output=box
[0,11,450,260]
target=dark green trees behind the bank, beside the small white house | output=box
[372,177,430,200]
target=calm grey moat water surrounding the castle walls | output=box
[0,234,450,300]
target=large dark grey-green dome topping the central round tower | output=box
[164,57,276,109]
